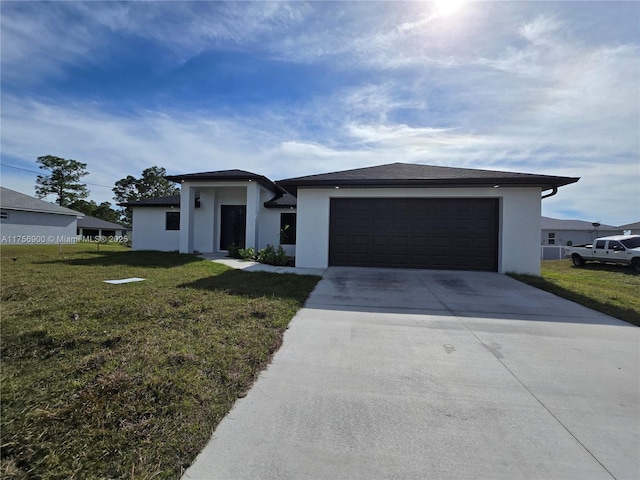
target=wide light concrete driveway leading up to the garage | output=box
[184,268,640,480]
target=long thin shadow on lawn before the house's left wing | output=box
[33,250,202,268]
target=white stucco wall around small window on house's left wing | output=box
[131,207,180,252]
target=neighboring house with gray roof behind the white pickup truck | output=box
[540,217,622,245]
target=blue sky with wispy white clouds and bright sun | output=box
[1,0,640,225]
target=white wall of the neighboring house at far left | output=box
[0,209,78,244]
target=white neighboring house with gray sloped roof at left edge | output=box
[0,187,84,244]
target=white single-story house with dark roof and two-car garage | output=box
[123,163,579,274]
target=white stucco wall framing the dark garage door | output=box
[296,188,541,275]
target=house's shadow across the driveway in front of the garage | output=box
[306,267,635,328]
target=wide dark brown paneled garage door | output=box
[329,198,498,271]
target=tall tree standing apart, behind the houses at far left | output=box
[36,155,89,207]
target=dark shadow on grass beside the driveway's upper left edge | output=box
[178,270,320,304]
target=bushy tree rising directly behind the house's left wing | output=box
[113,167,180,225]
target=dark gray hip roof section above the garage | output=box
[278,163,580,194]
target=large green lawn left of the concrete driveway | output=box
[0,244,319,479]
